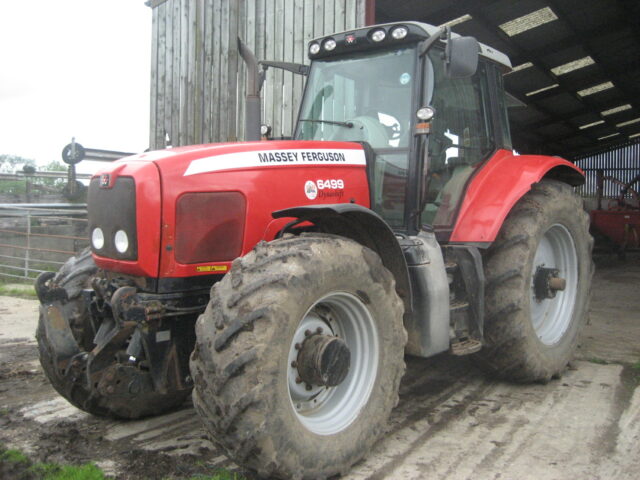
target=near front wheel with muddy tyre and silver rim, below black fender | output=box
[191,234,406,479]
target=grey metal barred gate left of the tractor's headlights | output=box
[0,203,89,281]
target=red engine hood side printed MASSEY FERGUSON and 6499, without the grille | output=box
[151,141,369,277]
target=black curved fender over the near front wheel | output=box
[272,203,411,314]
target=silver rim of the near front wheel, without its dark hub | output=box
[287,292,379,435]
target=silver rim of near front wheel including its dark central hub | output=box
[287,292,380,435]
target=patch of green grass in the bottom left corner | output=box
[0,446,106,480]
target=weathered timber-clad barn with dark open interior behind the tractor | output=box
[147,0,640,255]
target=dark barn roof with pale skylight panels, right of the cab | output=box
[375,0,640,158]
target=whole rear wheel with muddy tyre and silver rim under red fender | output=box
[478,180,593,382]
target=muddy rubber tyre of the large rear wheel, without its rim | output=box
[474,180,593,383]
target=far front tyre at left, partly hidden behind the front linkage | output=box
[35,248,191,419]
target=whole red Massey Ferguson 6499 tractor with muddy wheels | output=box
[36,22,592,478]
